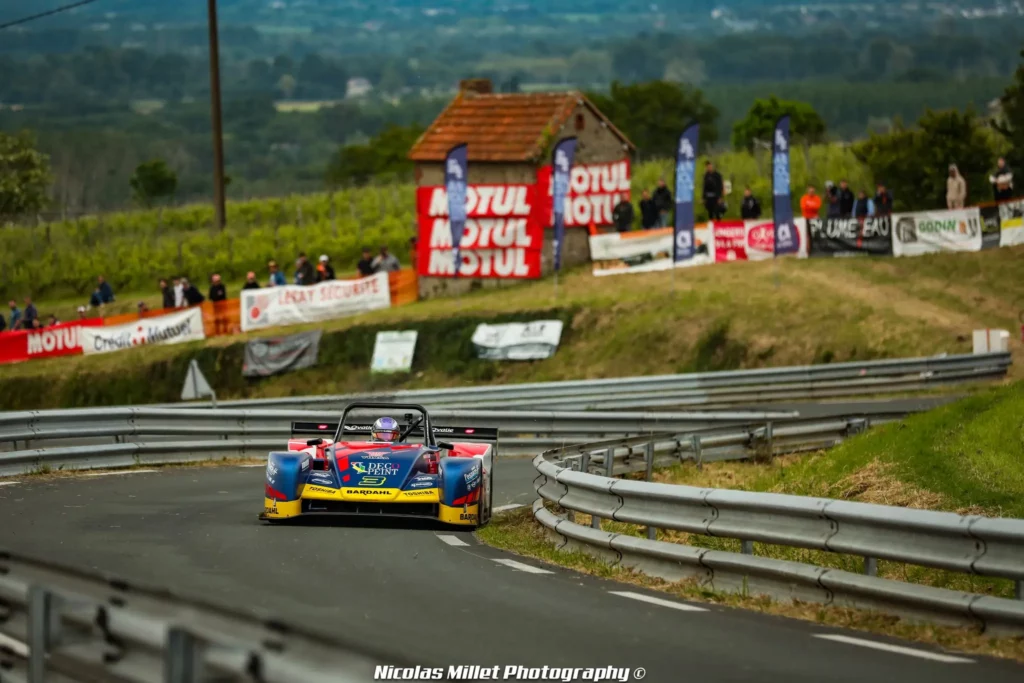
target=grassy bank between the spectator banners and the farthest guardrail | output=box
[0,241,1024,410]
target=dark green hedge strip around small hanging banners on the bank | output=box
[0,308,575,411]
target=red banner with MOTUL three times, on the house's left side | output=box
[417,185,544,278]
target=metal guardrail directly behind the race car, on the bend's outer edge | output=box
[0,408,799,475]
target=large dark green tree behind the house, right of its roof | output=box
[587,81,718,157]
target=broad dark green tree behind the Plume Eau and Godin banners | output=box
[853,108,997,210]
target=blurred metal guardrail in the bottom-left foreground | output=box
[0,552,400,683]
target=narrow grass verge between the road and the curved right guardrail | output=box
[477,508,1024,661]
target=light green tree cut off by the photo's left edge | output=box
[0,131,52,221]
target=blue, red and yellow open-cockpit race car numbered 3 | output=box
[260,402,498,527]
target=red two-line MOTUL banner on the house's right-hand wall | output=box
[537,159,631,227]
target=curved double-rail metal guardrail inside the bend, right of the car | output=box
[534,438,1024,634]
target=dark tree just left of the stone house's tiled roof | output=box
[326,125,423,187]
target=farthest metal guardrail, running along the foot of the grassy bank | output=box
[162,353,1011,411]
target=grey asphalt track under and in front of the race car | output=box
[0,450,1024,683]
